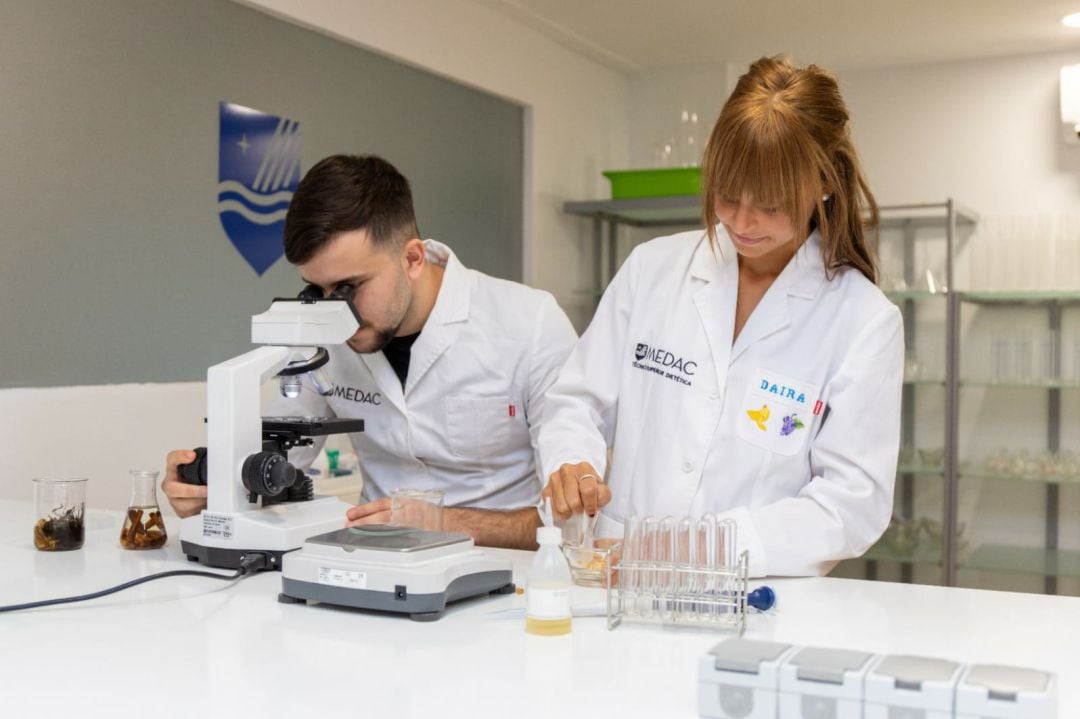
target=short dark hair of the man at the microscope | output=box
[285,154,419,264]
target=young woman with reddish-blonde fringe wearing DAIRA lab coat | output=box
[539,57,904,576]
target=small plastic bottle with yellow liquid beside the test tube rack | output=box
[525,520,572,636]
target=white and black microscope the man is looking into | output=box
[179,287,364,569]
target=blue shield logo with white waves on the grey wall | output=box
[217,103,300,274]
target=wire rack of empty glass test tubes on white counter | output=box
[606,515,750,636]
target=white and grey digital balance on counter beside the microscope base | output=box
[278,525,514,622]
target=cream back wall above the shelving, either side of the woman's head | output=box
[630,50,1080,289]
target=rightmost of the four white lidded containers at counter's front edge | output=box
[956,664,1057,719]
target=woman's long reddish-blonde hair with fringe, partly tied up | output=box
[702,56,878,282]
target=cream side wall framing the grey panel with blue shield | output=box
[0,0,630,508]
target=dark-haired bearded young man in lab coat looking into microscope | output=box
[162,155,577,548]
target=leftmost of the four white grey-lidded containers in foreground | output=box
[698,639,796,719]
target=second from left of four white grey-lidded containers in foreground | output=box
[780,647,874,719]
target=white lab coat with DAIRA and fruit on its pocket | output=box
[540,227,904,576]
